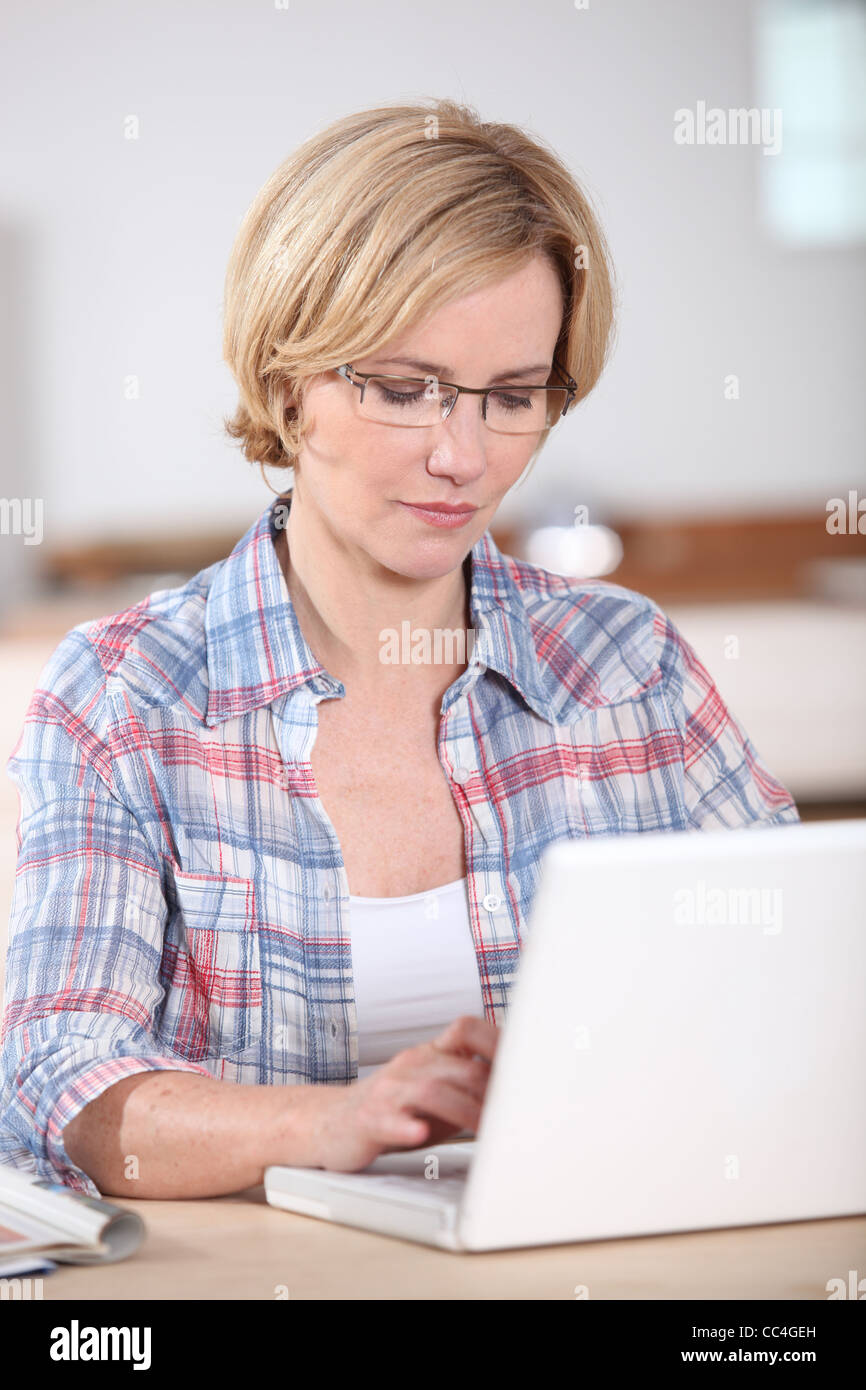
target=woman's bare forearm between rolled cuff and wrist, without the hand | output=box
[63,1072,329,1198]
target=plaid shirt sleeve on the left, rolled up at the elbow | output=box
[0,624,213,1195]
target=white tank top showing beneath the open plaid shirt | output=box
[349,878,484,1080]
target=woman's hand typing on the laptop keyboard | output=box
[316,1015,499,1173]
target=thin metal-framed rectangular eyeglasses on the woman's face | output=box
[334,361,577,434]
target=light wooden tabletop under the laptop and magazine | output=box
[37,1187,866,1301]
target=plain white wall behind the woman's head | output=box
[0,0,866,580]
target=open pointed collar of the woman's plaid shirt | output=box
[204,493,555,727]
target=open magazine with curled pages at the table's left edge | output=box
[0,1163,146,1277]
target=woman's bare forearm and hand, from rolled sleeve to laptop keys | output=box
[64,1016,499,1198]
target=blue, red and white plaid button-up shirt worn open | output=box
[0,500,798,1195]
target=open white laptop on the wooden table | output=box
[264,820,866,1251]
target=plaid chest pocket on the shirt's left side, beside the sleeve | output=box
[163,869,261,1062]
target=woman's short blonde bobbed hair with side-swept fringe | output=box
[222,100,613,478]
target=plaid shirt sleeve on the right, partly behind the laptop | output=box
[655,609,799,830]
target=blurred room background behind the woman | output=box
[0,0,866,956]
